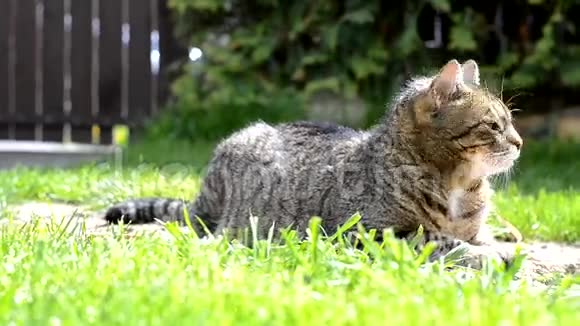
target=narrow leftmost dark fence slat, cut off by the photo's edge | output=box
[0,0,10,139]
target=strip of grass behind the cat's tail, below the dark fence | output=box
[0,141,213,209]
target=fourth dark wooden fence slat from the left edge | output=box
[71,0,92,143]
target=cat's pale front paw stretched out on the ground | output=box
[457,244,515,269]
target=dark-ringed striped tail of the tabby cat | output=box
[105,198,195,224]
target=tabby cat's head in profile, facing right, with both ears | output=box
[406,60,523,177]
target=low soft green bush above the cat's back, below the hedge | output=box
[148,61,304,141]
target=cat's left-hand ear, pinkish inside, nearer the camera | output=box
[429,59,463,106]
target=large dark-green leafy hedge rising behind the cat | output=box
[152,0,580,137]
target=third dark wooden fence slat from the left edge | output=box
[43,0,64,141]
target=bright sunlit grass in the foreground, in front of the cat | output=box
[0,216,580,326]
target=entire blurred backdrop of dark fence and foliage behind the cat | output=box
[0,0,580,149]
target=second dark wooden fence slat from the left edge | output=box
[15,0,36,140]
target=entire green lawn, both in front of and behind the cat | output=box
[0,142,580,326]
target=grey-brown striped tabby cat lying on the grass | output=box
[105,59,523,268]
